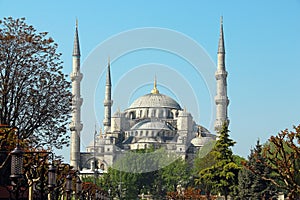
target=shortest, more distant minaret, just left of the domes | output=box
[103,58,113,133]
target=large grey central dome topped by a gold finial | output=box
[129,93,181,110]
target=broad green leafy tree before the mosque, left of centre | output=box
[101,148,166,199]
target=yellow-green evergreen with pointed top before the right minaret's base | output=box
[197,124,240,200]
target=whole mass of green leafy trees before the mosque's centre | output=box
[100,148,190,199]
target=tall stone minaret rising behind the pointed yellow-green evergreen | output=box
[215,17,229,131]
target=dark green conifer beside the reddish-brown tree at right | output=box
[238,140,276,199]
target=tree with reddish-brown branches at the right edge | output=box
[262,125,300,199]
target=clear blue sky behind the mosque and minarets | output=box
[0,0,300,160]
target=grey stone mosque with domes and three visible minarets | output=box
[70,20,229,172]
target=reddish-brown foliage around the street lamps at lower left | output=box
[0,125,75,199]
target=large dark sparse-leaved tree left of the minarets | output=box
[0,17,71,148]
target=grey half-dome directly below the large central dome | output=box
[131,120,172,130]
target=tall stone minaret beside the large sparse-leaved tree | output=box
[70,20,82,170]
